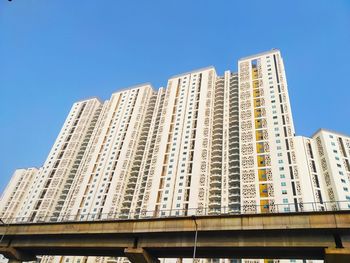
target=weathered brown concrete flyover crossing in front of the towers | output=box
[0,211,350,263]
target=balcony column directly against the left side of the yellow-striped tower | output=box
[228,73,240,212]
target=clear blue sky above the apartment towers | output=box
[0,0,350,194]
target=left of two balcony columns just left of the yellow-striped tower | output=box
[209,77,225,213]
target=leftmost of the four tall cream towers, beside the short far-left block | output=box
[17,99,101,221]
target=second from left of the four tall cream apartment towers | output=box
[61,84,156,219]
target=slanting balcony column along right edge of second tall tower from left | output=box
[120,93,157,218]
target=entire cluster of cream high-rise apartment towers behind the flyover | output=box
[0,50,350,263]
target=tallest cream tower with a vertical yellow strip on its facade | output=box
[238,50,312,213]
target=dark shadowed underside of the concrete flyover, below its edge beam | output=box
[0,230,346,259]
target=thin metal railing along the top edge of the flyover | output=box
[0,200,350,225]
